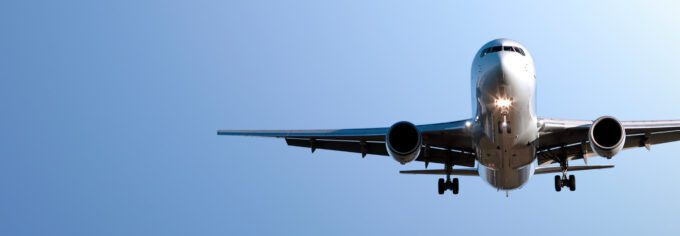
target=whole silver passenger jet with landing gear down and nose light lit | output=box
[217,39,680,195]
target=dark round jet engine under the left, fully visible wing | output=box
[385,121,423,165]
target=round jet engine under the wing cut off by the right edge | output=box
[588,116,626,159]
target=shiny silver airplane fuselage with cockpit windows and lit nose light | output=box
[471,39,539,190]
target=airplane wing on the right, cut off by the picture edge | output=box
[537,119,680,166]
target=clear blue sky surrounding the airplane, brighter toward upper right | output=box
[0,0,680,235]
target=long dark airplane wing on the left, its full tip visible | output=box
[217,120,475,167]
